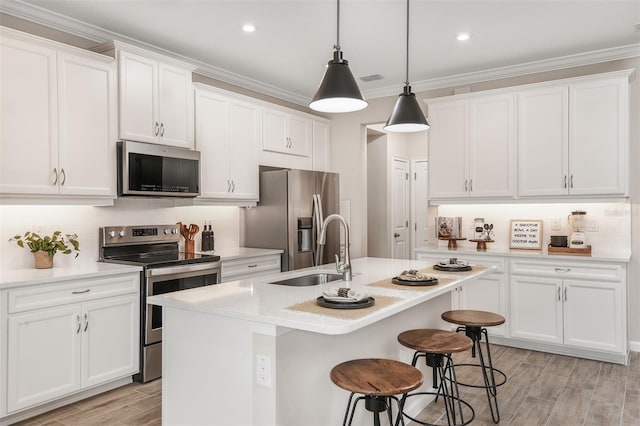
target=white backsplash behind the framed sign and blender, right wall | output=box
[430,202,631,255]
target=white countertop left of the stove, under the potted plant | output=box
[0,262,142,290]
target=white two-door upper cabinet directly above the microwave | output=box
[96,42,195,149]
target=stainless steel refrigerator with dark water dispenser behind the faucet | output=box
[244,169,340,271]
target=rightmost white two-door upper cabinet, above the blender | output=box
[517,75,629,197]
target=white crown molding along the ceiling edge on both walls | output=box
[0,0,640,106]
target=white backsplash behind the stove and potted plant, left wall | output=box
[0,199,239,269]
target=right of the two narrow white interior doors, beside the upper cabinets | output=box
[411,159,429,257]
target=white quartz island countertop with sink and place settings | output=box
[148,258,491,334]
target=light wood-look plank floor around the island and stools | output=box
[12,345,640,426]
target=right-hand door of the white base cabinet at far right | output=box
[563,280,626,353]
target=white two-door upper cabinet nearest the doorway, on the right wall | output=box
[429,94,515,199]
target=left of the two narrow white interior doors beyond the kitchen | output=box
[391,158,409,259]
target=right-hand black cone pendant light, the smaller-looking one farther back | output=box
[384,0,429,132]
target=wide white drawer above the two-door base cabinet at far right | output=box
[511,260,626,282]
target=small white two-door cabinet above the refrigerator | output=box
[262,108,312,157]
